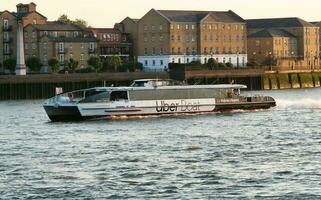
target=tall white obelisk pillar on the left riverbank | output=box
[16,21,27,76]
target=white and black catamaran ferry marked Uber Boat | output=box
[43,79,276,121]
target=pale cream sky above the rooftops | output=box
[0,0,321,27]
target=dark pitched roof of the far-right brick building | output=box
[246,17,314,28]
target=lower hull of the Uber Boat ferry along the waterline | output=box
[44,100,276,121]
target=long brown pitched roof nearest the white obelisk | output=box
[30,23,82,31]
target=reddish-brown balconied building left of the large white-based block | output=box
[88,28,132,62]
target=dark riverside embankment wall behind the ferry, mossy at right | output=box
[0,69,321,100]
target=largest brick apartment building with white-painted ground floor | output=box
[122,9,247,70]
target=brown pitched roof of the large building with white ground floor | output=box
[156,10,244,22]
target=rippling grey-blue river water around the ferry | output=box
[0,89,321,199]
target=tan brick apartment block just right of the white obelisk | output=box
[24,22,97,71]
